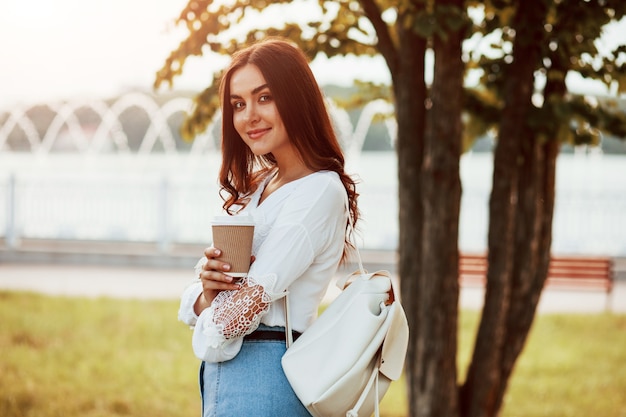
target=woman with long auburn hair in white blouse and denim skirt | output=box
[179,39,359,417]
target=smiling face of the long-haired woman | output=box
[230,64,293,160]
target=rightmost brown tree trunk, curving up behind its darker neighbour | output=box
[497,60,567,408]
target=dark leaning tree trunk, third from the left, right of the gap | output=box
[461,0,545,417]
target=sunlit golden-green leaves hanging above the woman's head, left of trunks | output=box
[154,0,388,140]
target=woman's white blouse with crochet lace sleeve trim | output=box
[178,171,348,362]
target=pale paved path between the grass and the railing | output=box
[0,256,626,313]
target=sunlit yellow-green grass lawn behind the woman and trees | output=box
[0,292,626,417]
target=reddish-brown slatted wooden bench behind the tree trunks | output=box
[459,254,614,305]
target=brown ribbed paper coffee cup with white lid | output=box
[211,215,254,278]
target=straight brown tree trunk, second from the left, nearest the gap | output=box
[410,0,464,417]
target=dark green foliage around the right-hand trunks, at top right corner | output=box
[465,0,626,146]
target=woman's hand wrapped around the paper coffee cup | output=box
[193,248,240,315]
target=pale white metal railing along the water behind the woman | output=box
[0,155,626,256]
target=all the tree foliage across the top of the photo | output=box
[155,0,626,149]
